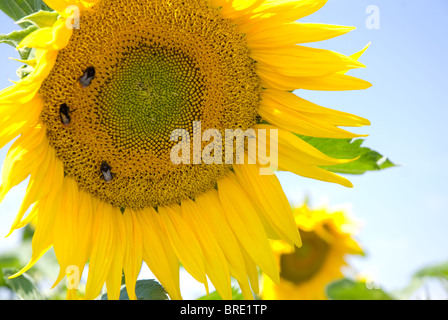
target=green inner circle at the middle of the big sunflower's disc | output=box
[98,45,205,155]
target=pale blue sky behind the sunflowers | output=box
[0,0,448,298]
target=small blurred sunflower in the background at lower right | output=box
[262,204,363,300]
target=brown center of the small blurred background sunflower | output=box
[280,231,330,284]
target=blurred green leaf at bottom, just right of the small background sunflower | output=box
[326,279,393,300]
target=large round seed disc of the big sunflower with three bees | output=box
[40,0,261,208]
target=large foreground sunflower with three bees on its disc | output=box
[0,0,370,299]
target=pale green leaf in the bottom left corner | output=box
[2,268,44,300]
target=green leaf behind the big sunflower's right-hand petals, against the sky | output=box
[298,135,396,174]
